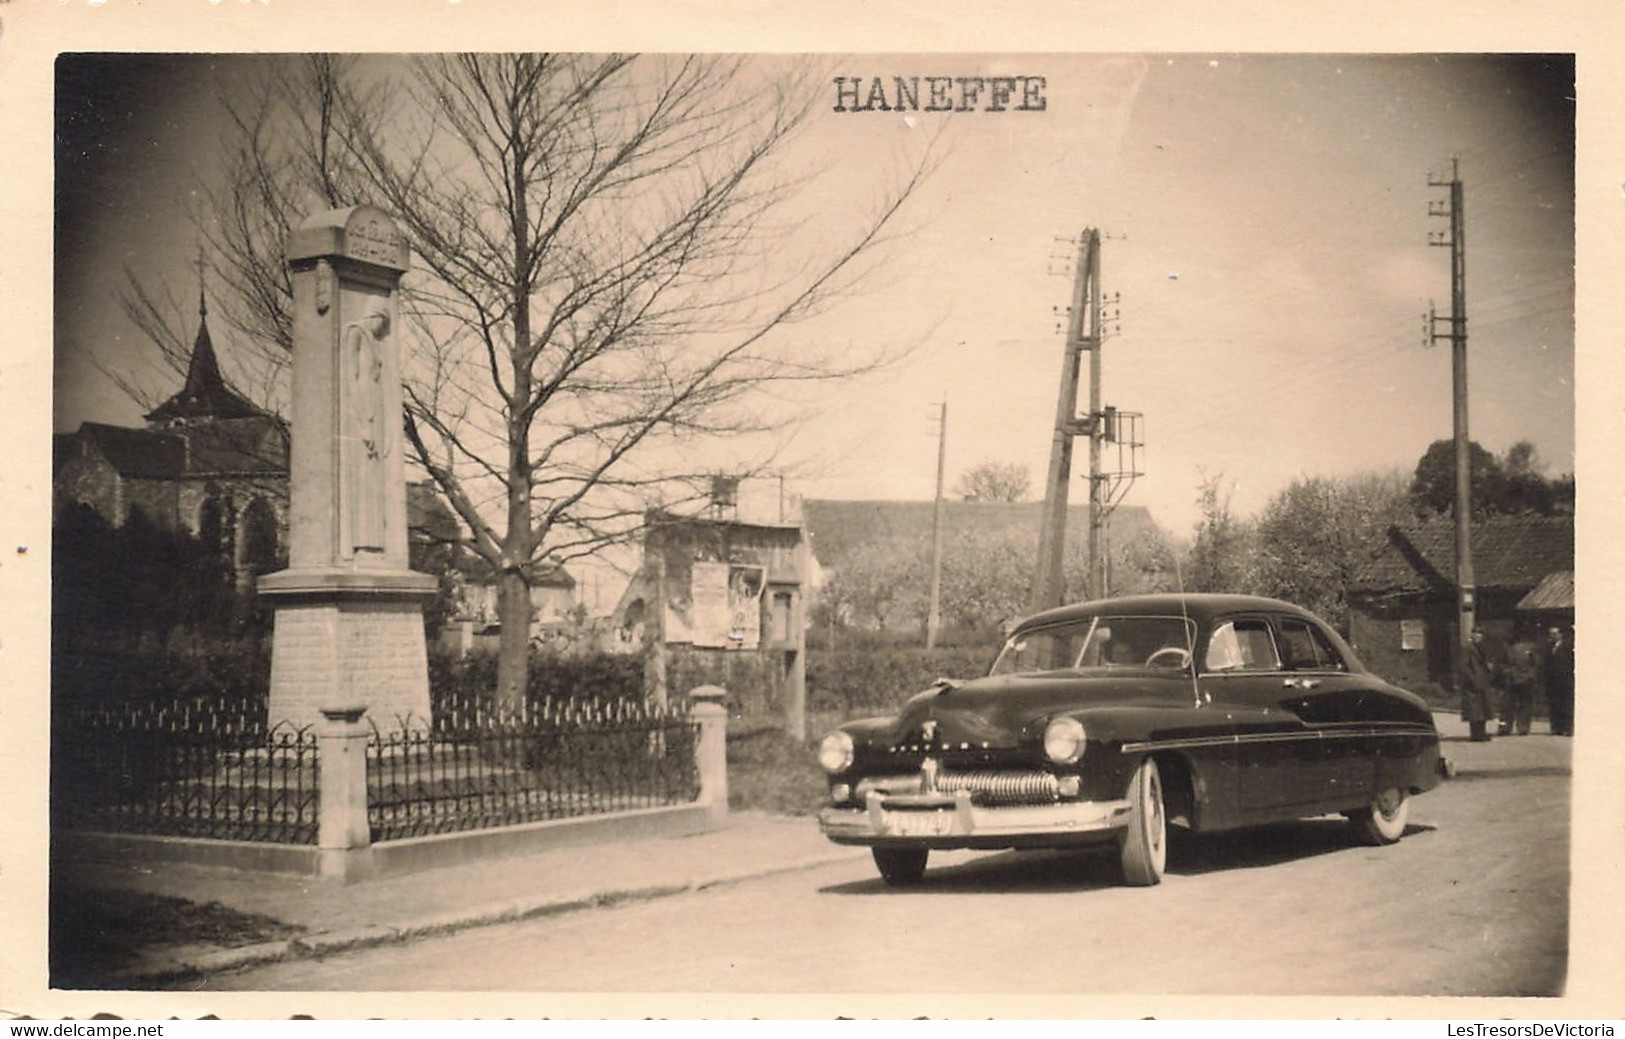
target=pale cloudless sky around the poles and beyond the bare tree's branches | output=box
[54,54,1575,537]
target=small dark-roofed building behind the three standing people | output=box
[1349,515,1575,688]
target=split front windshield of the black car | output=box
[988,615,1196,675]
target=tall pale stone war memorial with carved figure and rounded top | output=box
[258,205,436,728]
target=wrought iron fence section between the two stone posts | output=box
[367,699,699,841]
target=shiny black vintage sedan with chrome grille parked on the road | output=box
[819,595,1448,885]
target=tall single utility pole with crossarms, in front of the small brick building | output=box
[1428,159,1477,647]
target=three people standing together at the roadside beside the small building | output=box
[1456,628,1575,743]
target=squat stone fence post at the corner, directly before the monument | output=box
[317,707,372,881]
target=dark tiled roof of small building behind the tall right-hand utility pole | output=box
[1352,515,1575,597]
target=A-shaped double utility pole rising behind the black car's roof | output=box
[1032,228,1100,613]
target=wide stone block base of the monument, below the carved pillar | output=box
[258,567,437,728]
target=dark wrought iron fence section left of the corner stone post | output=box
[50,699,317,844]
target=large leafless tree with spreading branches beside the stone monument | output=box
[120,55,933,702]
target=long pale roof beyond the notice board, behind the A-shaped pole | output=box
[801,499,1157,566]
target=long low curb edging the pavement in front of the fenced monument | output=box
[111,849,856,987]
